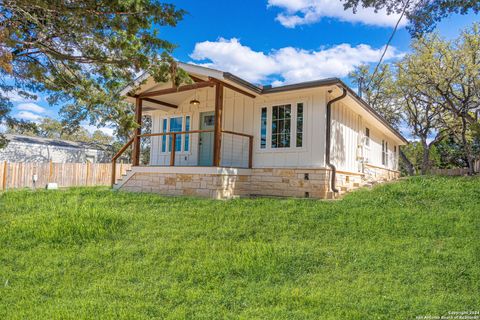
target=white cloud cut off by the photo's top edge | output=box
[268,0,407,28]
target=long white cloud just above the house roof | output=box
[191,38,402,85]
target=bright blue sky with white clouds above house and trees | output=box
[5,0,478,134]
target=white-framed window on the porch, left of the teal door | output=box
[161,115,191,153]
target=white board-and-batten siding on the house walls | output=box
[148,88,399,172]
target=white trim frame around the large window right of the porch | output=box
[255,98,309,153]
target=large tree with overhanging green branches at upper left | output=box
[0,0,188,142]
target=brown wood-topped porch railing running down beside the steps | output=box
[112,129,253,185]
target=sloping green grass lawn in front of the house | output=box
[0,177,480,319]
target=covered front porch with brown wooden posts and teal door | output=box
[112,69,256,185]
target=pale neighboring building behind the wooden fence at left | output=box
[0,134,112,163]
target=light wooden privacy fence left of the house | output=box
[0,161,131,190]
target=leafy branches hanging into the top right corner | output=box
[344,0,480,36]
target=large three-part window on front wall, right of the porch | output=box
[259,102,305,150]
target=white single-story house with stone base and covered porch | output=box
[112,63,407,199]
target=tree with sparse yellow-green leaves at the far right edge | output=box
[410,24,480,174]
